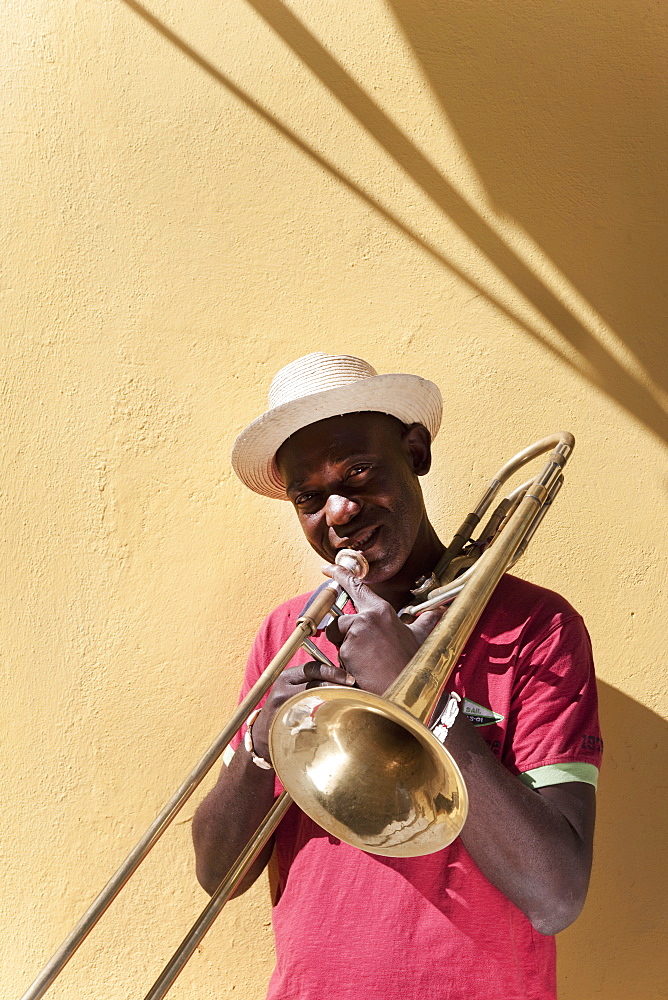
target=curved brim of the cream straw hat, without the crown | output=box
[231,375,443,500]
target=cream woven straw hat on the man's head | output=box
[232,353,443,500]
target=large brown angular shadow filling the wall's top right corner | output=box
[387,0,668,426]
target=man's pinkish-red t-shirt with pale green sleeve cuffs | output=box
[234,575,602,1000]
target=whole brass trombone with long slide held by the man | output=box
[21,432,575,1000]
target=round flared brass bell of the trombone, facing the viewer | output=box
[270,687,468,858]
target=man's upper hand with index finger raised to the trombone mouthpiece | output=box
[323,566,442,694]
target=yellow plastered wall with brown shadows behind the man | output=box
[0,0,668,1000]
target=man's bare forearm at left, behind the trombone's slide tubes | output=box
[192,744,276,895]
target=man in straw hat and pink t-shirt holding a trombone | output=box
[193,354,601,1000]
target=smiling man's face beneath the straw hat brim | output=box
[276,412,430,583]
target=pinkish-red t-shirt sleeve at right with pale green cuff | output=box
[504,615,603,788]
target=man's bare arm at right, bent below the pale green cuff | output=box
[446,715,593,934]
